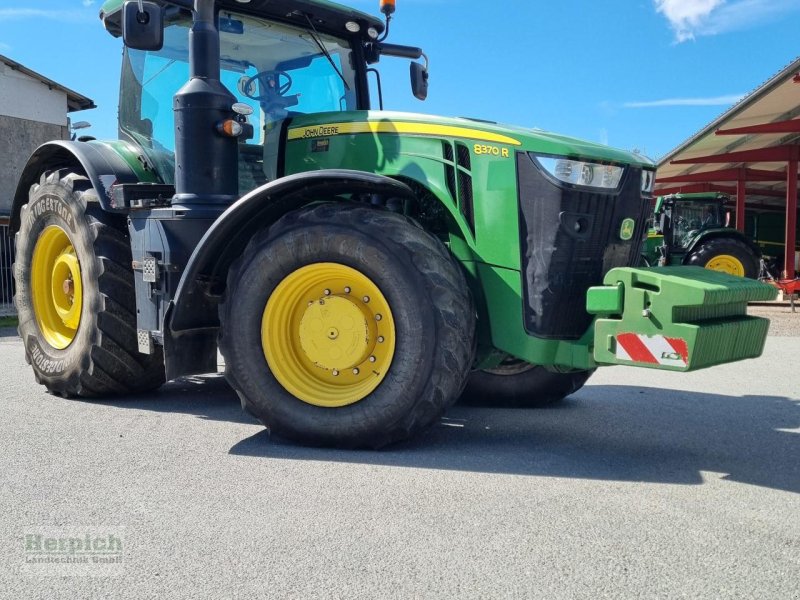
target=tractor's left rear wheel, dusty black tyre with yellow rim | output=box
[14,171,164,398]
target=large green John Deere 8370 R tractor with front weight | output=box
[13,0,775,447]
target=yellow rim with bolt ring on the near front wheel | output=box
[261,263,395,408]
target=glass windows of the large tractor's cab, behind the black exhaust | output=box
[120,11,358,193]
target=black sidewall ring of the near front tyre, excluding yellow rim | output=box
[223,225,437,444]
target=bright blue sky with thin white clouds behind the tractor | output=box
[0,0,800,158]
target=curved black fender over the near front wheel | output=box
[163,169,415,379]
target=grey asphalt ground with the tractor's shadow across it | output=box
[0,326,800,600]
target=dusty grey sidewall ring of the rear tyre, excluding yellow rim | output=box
[14,182,101,389]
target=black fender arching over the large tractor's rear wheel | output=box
[11,140,161,231]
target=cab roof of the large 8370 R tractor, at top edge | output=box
[100,0,384,37]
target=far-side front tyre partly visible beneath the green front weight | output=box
[460,360,594,408]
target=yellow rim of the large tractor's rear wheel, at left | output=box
[31,225,83,350]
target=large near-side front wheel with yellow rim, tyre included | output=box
[219,203,475,448]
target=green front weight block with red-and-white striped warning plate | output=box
[586,267,777,371]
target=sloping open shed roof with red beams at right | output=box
[656,57,800,205]
